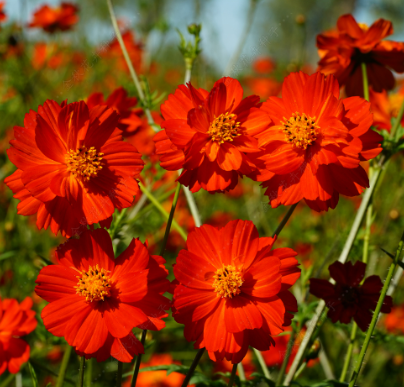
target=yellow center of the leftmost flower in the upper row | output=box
[66,146,104,181]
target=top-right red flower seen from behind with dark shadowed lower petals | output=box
[317,15,404,96]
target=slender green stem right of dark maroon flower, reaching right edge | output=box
[349,233,404,387]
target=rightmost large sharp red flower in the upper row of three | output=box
[251,72,382,211]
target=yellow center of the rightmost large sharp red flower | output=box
[281,112,320,149]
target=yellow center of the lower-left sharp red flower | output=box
[74,265,111,302]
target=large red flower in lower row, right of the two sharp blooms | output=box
[173,220,300,364]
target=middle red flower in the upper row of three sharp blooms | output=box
[154,77,270,193]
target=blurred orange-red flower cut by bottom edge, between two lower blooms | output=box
[123,353,194,387]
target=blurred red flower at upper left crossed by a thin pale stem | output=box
[98,31,143,72]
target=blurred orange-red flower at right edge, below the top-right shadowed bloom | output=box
[369,86,404,131]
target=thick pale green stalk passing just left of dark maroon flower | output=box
[284,169,383,386]
